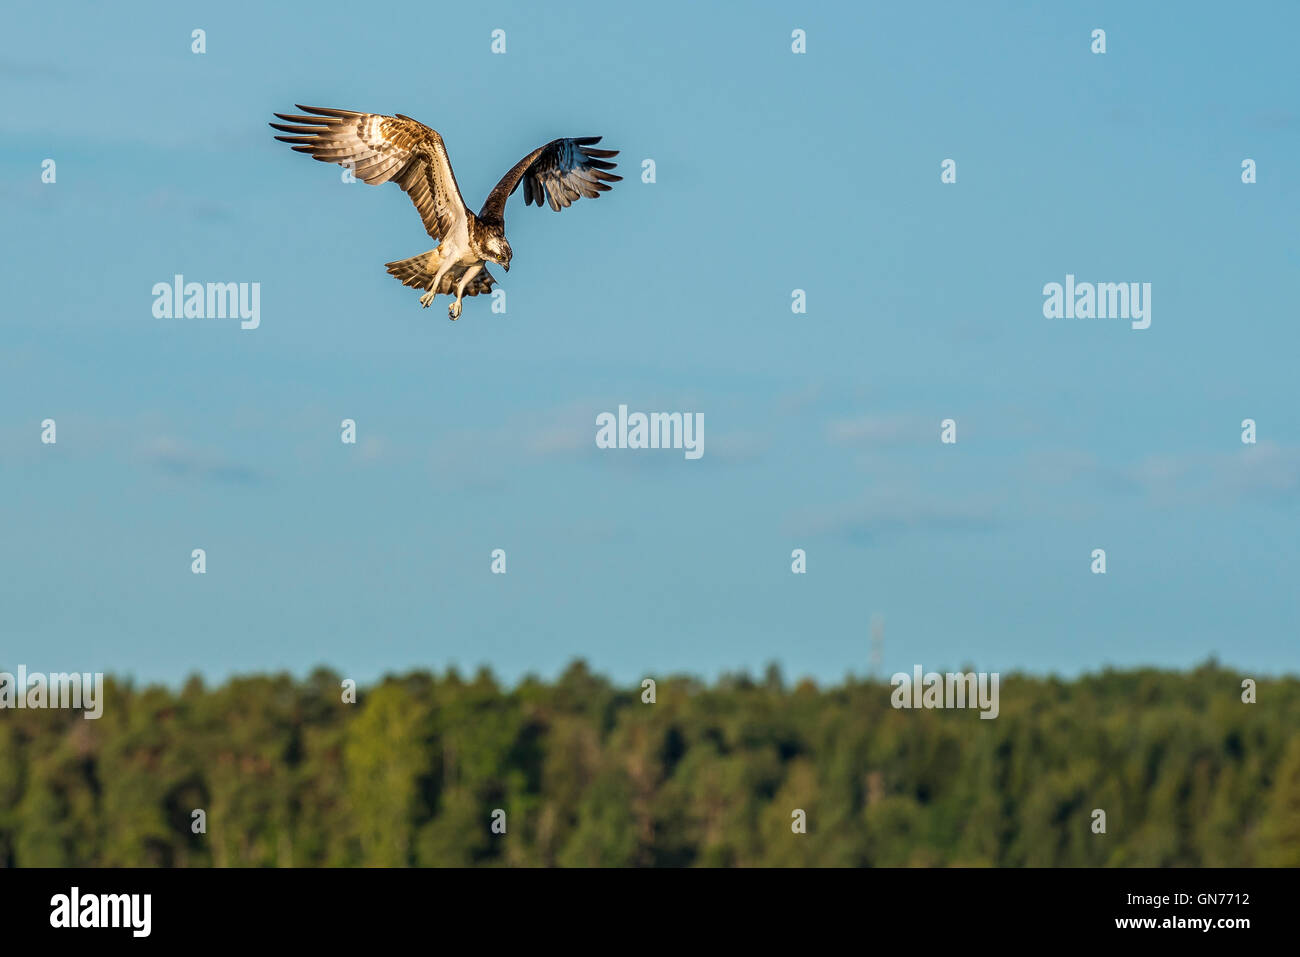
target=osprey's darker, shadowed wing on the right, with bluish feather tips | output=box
[478,137,623,222]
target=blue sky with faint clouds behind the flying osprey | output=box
[0,1,1300,681]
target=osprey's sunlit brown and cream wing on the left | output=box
[270,104,469,242]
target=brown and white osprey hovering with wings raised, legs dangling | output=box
[270,104,623,319]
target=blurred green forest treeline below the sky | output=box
[0,663,1300,867]
